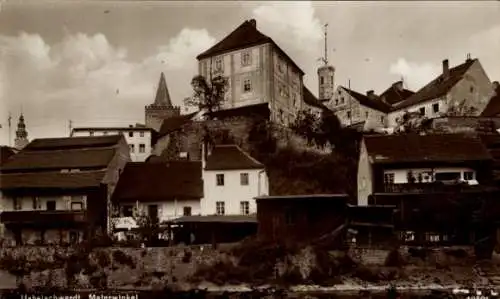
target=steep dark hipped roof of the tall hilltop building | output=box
[196,20,304,75]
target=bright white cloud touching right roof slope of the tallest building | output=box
[253,1,323,90]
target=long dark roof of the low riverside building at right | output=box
[364,134,492,164]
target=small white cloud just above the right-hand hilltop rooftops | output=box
[389,58,439,90]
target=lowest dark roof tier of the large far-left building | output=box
[0,171,106,190]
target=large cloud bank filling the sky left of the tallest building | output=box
[0,28,215,143]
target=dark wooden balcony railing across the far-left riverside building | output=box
[0,210,87,226]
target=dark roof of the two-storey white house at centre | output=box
[205,145,264,170]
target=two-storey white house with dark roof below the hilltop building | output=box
[200,145,269,215]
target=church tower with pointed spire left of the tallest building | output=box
[145,73,181,131]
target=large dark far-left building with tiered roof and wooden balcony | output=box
[0,136,130,245]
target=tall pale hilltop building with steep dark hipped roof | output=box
[197,19,304,125]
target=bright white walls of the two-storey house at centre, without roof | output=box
[201,169,269,215]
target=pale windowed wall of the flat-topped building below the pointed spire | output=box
[71,128,152,162]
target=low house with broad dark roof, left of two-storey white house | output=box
[113,161,203,227]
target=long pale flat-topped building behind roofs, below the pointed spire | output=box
[70,125,153,162]
